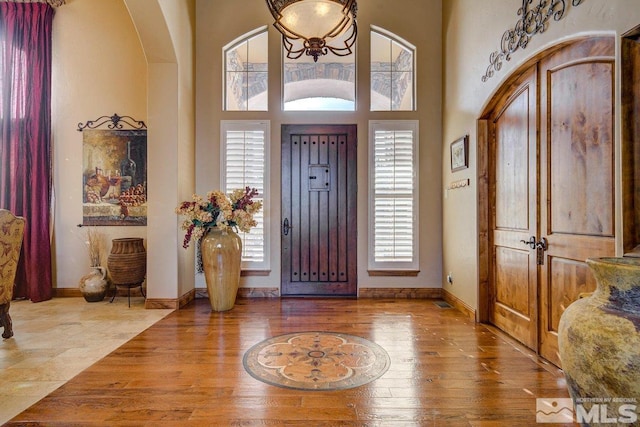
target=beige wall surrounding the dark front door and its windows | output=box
[196,0,442,288]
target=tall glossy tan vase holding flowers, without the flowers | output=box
[200,227,242,311]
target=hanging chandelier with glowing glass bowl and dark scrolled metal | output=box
[266,0,358,62]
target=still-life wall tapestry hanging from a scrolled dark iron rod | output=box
[78,114,147,225]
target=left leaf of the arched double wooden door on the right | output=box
[489,66,538,348]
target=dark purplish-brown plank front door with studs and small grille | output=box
[281,125,357,296]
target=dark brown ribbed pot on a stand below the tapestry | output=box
[107,237,147,286]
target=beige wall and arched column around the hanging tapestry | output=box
[52,0,195,299]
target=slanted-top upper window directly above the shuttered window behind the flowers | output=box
[223,26,269,111]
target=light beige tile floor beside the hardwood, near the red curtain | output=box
[0,297,173,425]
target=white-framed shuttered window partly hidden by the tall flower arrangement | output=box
[220,121,270,270]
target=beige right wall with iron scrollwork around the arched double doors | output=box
[442,0,640,314]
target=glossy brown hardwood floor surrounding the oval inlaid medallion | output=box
[6,299,572,427]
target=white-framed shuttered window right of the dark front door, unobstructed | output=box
[369,120,419,271]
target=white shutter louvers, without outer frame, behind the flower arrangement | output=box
[224,129,266,263]
